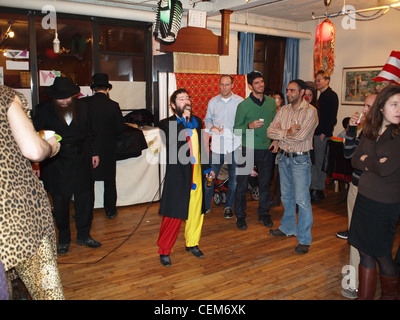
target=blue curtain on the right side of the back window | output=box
[282,38,300,93]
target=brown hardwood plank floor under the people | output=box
[59,185,399,300]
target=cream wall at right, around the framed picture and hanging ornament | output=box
[299,9,400,134]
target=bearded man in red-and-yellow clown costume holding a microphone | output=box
[157,89,215,266]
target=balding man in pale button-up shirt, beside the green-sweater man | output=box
[204,74,243,219]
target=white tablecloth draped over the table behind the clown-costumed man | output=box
[94,127,162,208]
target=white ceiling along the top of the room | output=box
[61,0,399,22]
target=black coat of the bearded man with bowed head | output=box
[33,99,97,196]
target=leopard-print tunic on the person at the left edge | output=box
[0,85,57,271]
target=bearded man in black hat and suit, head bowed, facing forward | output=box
[33,77,101,254]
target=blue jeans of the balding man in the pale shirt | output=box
[205,149,238,210]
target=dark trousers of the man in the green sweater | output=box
[235,147,272,218]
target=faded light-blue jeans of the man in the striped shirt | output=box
[277,153,313,245]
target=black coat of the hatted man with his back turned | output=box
[82,93,126,181]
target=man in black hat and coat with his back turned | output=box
[83,73,126,219]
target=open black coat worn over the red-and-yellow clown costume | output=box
[159,116,210,220]
